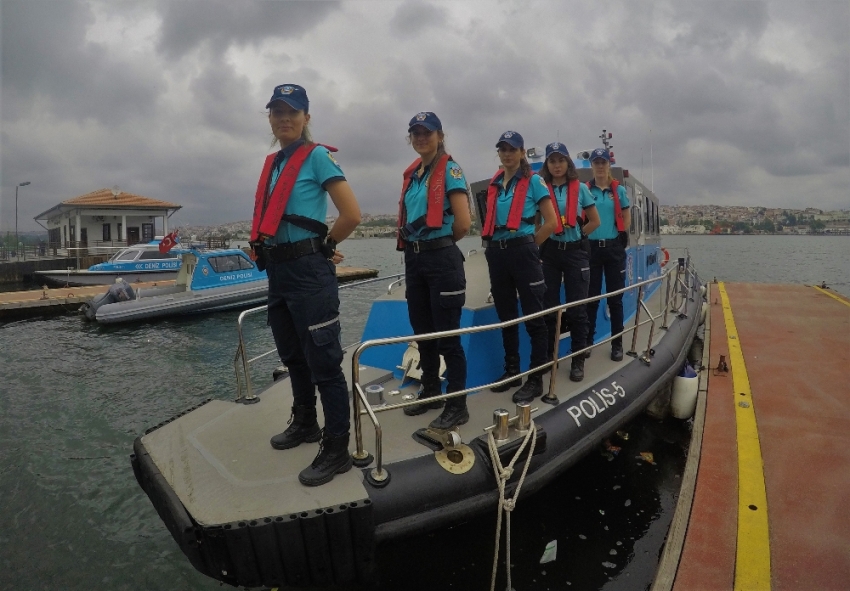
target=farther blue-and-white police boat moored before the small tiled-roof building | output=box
[33,240,187,287]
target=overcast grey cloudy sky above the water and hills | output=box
[0,0,850,231]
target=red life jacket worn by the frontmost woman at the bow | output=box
[251,143,337,241]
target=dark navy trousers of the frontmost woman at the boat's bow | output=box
[266,253,351,435]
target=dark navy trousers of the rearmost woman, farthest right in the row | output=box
[587,240,626,346]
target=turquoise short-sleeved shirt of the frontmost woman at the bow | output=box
[266,140,345,245]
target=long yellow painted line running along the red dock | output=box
[719,283,770,591]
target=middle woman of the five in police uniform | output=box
[481,131,557,402]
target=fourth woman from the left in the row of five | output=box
[540,142,599,382]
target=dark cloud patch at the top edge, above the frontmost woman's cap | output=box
[157,0,339,59]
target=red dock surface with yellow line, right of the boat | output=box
[653,283,850,591]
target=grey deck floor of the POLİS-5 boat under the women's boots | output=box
[142,282,675,525]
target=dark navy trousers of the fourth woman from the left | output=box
[543,240,590,353]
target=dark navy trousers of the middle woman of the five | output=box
[484,242,552,367]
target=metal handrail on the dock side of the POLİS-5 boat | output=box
[351,264,696,482]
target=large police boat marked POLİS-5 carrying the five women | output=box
[131,151,703,587]
